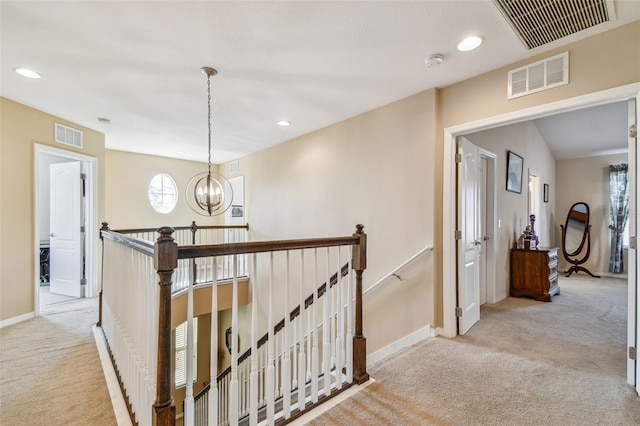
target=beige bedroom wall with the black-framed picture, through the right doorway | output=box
[466,122,556,299]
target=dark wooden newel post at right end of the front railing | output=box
[352,225,369,384]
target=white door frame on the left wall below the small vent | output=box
[33,143,98,316]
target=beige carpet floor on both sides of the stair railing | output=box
[0,275,640,426]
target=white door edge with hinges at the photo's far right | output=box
[627,99,640,393]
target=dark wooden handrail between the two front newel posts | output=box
[178,237,360,259]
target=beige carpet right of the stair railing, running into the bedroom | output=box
[310,274,640,426]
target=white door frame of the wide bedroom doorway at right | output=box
[439,82,640,337]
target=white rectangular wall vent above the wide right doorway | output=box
[507,52,569,99]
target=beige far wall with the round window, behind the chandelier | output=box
[105,150,219,229]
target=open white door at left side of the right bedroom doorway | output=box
[457,137,482,334]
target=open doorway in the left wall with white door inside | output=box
[34,144,97,316]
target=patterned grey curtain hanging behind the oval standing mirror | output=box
[609,164,629,273]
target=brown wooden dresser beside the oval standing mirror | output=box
[511,247,560,302]
